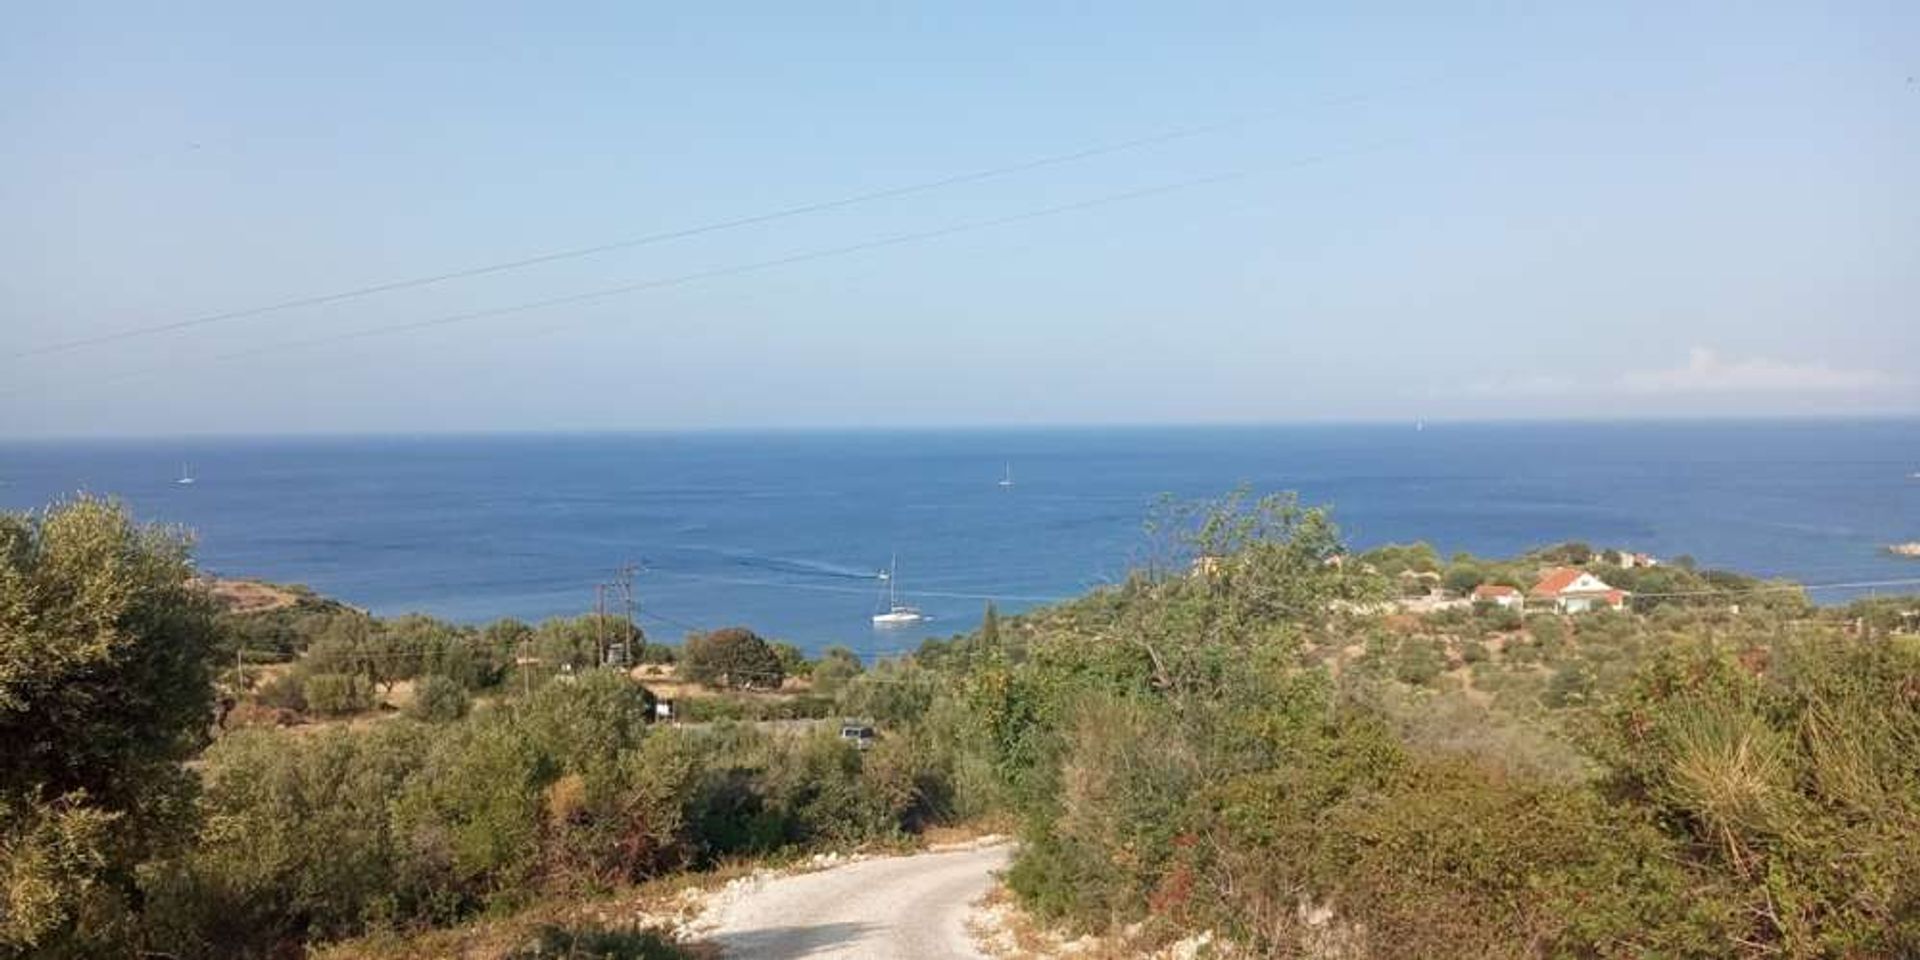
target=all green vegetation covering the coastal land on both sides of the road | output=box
[0,495,1920,958]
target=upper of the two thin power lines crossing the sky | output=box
[10,68,1446,359]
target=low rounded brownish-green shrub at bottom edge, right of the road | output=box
[1305,760,1713,960]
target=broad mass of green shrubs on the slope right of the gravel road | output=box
[975,501,1920,958]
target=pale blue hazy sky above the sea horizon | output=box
[0,2,1920,436]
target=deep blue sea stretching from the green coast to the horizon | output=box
[0,420,1920,653]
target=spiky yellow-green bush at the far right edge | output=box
[1596,639,1920,956]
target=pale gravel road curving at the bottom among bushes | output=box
[699,843,1012,960]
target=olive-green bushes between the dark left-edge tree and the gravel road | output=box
[144,670,697,956]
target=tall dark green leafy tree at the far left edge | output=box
[0,497,215,954]
